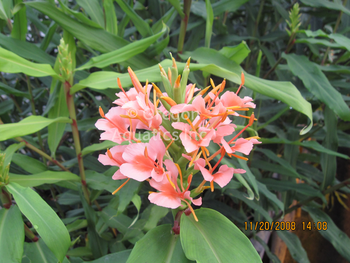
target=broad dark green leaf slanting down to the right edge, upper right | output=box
[282,53,350,121]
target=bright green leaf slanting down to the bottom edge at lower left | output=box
[6,182,70,262]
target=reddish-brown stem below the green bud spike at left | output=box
[64,81,90,204]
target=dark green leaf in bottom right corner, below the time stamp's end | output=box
[303,206,350,261]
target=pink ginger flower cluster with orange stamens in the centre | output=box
[96,59,260,220]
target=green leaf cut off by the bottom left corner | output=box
[0,205,24,263]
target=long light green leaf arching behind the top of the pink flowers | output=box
[71,48,312,134]
